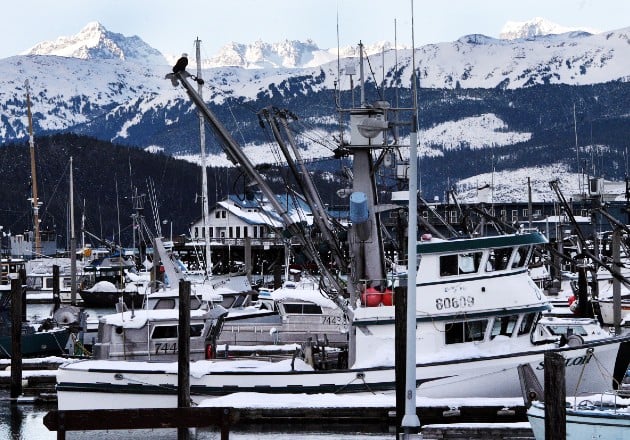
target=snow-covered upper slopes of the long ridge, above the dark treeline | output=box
[0,23,630,144]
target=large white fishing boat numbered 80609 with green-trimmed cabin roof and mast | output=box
[57,49,630,410]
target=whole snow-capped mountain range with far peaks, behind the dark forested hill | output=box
[0,18,630,201]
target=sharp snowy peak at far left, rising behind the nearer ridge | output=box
[22,21,168,65]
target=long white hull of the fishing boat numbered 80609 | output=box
[57,337,629,410]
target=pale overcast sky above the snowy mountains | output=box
[0,0,630,58]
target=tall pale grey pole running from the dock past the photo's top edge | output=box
[401,0,420,432]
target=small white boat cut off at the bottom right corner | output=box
[527,393,630,440]
